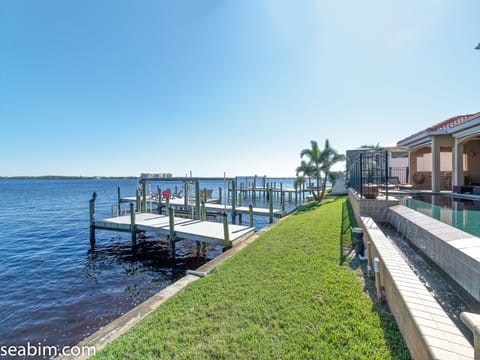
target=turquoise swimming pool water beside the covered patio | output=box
[402,194,480,237]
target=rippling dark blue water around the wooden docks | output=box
[0,180,296,352]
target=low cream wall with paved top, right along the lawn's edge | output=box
[360,217,474,360]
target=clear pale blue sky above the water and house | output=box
[0,0,480,176]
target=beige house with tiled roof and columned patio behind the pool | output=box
[397,112,480,192]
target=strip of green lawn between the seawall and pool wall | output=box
[96,198,409,359]
